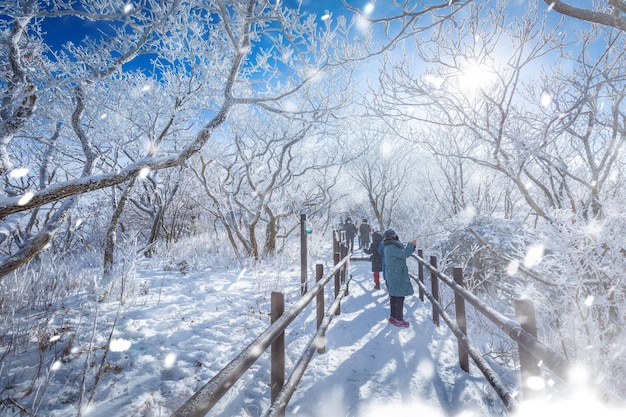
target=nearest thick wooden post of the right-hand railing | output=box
[515,299,541,400]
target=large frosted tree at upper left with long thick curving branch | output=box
[0,0,356,274]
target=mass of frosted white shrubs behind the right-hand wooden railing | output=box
[424,212,626,398]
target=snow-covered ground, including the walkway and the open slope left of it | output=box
[0,249,623,417]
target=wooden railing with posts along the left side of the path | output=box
[172,232,351,417]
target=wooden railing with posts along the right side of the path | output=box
[410,250,568,410]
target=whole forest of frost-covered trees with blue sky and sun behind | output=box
[0,0,626,412]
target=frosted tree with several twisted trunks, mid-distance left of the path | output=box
[190,101,343,259]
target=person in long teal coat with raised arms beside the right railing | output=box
[383,228,417,327]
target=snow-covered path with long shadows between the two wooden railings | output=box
[287,262,502,417]
